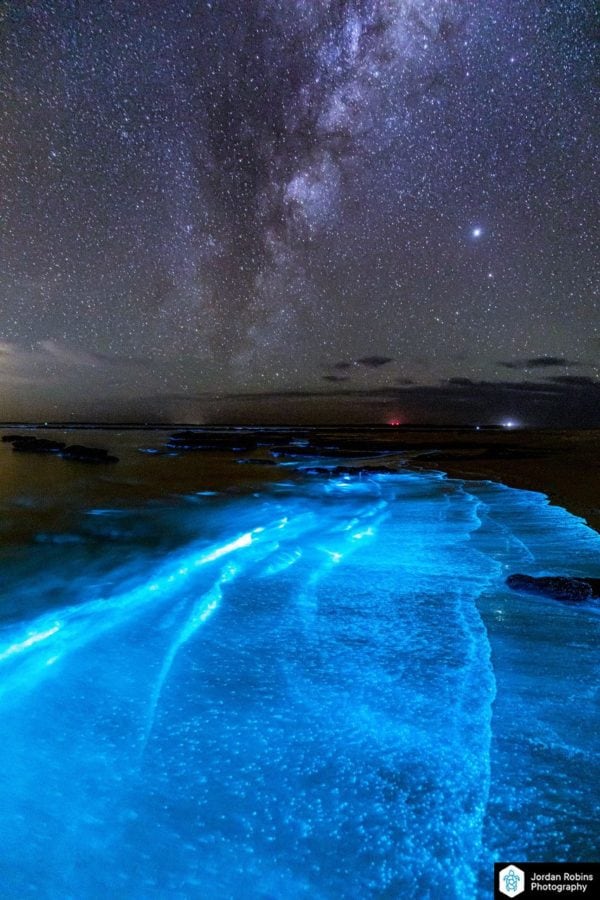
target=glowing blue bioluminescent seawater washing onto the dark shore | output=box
[0,432,600,900]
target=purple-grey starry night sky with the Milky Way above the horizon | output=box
[0,0,600,426]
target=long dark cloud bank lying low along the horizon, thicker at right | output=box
[35,379,600,428]
